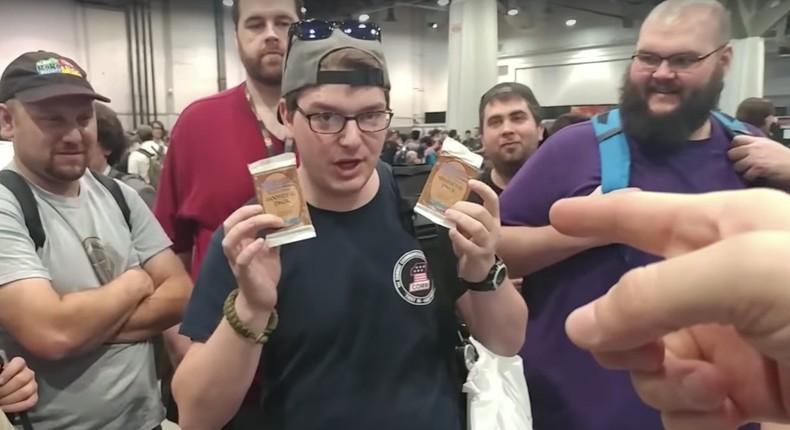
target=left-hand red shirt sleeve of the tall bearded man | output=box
[154,120,196,253]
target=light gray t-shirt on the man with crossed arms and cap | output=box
[0,166,171,430]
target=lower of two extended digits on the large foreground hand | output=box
[566,232,790,363]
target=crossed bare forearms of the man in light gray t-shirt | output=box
[0,250,191,360]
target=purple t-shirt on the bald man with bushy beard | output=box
[500,120,759,430]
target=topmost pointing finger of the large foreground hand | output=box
[549,189,790,257]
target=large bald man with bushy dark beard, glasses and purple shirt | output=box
[499,0,788,430]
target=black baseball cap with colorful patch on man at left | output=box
[0,51,110,103]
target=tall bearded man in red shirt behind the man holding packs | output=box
[154,0,301,421]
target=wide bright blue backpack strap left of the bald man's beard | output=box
[591,109,631,193]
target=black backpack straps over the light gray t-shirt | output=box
[0,170,132,251]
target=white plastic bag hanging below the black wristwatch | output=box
[463,338,532,430]
